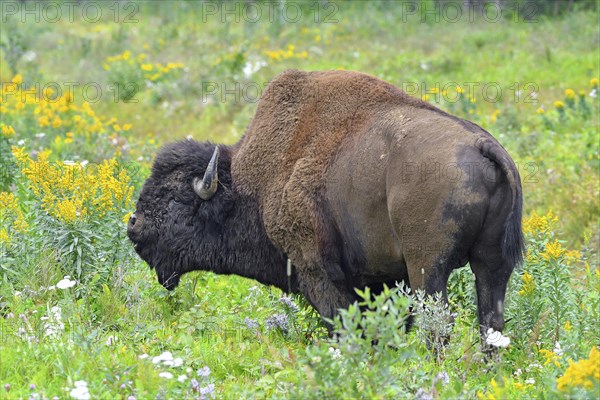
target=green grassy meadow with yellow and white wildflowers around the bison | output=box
[0,2,600,399]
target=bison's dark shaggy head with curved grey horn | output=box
[127,140,232,290]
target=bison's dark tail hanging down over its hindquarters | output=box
[477,139,525,266]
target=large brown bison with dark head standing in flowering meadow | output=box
[128,70,524,332]
